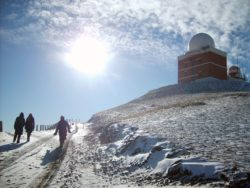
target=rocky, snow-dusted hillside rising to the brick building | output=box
[86,78,250,187]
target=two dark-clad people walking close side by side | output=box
[13,112,35,143]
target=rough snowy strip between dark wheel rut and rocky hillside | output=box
[46,124,106,188]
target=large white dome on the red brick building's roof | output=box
[189,33,215,51]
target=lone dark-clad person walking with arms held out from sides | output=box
[54,116,71,147]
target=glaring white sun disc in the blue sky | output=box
[65,37,110,76]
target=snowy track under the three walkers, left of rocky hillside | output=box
[0,124,176,188]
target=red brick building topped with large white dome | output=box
[178,33,227,84]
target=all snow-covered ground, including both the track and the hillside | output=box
[0,78,250,188]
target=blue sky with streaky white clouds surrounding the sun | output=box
[0,0,250,131]
